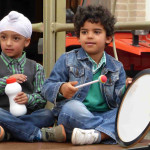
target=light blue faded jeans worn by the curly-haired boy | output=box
[58,100,117,144]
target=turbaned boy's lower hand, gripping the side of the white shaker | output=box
[14,92,28,104]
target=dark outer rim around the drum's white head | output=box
[115,69,150,147]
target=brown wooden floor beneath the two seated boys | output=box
[0,139,150,150]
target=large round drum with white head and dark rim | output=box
[116,69,150,147]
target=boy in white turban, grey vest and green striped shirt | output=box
[0,11,66,142]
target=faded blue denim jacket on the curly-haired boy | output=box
[42,48,126,115]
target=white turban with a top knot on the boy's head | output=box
[0,11,32,38]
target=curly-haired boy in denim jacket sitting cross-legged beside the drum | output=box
[42,5,126,145]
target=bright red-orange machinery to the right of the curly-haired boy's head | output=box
[106,32,150,71]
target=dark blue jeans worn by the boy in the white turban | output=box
[0,108,55,142]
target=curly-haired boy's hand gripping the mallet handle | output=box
[59,81,78,99]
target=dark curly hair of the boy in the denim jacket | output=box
[73,5,116,37]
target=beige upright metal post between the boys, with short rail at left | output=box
[36,0,66,77]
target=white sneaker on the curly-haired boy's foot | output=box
[71,128,100,145]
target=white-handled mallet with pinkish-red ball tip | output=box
[76,75,107,88]
